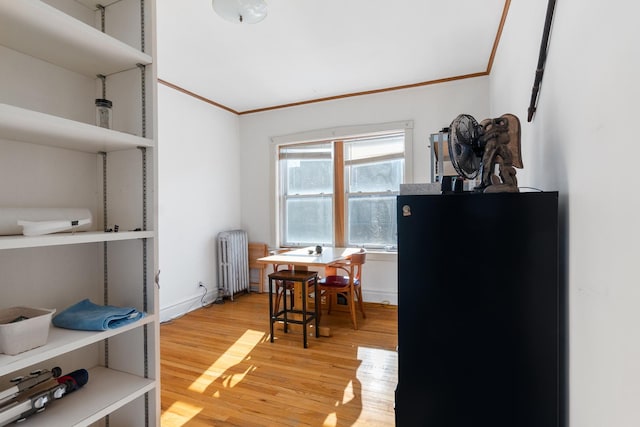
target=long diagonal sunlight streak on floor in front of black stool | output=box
[189,329,265,393]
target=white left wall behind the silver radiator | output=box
[158,84,242,321]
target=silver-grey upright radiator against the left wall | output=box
[218,230,249,301]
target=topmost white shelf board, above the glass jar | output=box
[0,0,152,77]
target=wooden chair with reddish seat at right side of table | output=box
[318,250,367,329]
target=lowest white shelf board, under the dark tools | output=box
[14,367,156,427]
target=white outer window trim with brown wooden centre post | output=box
[270,120,413,247]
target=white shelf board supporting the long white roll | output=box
[0,231,155,249]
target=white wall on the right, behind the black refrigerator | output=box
[491,0,640,427]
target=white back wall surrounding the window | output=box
[240,77,489,304]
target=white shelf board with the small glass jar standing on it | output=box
[0,104,153,153]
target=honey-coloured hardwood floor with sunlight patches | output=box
[160,293,398,427]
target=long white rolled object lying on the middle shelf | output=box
[0,207,92,236]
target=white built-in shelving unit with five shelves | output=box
[0,0,160,427]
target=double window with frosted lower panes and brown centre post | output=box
[276,123,407,248]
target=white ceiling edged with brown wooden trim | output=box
[157,0,509,113]
